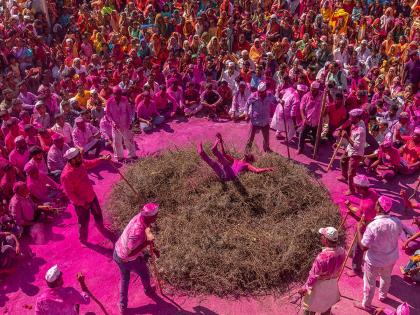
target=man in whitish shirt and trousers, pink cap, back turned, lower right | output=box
[354,196,402,311]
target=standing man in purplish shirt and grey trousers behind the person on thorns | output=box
[245,82,277,152]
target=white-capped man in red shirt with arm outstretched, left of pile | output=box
[61,148,114,245]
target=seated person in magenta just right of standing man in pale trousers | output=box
[136,91,165,132]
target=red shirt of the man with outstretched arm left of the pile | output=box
[61,159,102,206]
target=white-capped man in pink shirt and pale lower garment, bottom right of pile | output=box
[299,227,346,315]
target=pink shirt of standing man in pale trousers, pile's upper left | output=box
[106,96,133,130]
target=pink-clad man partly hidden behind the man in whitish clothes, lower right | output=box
[345,175,378,276]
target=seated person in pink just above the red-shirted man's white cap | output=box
[73,117,103,157]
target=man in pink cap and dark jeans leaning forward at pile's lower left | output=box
[114,203,159,314]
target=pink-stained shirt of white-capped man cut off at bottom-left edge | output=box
[35,287,90,315]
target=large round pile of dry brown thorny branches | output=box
[107,148,340,296]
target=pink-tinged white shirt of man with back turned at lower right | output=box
[361,215,402,267]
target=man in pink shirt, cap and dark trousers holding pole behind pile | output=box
[298,81,322,154]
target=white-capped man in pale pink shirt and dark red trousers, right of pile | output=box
[339,108,366,195]
